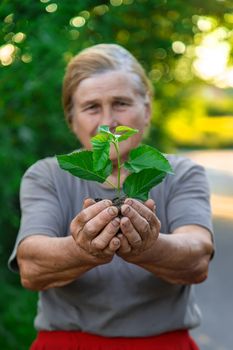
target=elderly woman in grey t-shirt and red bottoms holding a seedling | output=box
[9,44,213,350]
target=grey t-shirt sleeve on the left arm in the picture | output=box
[8,160,65,271]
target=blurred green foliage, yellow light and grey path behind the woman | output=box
[0,0,233,350]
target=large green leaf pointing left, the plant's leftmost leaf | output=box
[56,151,112,183]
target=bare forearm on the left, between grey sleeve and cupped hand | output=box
[17,235,97,290]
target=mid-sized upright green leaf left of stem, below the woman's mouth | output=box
[91,133,111,170]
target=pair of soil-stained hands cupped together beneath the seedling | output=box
[70,198,160,265]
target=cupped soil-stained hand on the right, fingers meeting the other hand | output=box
[117,198,161,262]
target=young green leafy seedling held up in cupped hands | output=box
[57,125,174,201]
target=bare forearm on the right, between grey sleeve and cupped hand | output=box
[129,232,213,284]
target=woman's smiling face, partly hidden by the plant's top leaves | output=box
[72,71,150,161]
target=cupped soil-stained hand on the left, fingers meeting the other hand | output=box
[70,198,120,264]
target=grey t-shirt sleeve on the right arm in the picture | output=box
[167,158,213,237]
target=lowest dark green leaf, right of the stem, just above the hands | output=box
[123,169,166,201]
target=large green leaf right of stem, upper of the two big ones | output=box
[124,145,174,174]
